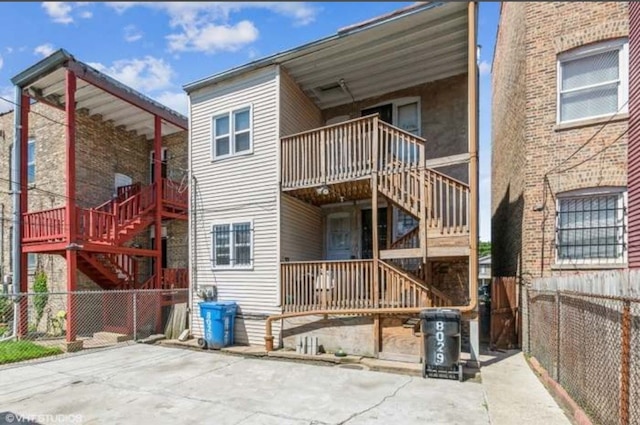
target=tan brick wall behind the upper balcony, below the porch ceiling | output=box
[322,73,468,182]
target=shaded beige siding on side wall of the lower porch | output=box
[280,194,324,261]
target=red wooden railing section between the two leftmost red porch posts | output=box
[22,207,67,243]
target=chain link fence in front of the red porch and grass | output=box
[0,289,188,365]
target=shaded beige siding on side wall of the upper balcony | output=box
[280,69,323,136]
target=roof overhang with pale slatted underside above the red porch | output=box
[11,49,188,138]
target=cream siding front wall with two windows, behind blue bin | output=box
[190,67,281,344]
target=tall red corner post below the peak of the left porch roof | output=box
[65,69,78,342]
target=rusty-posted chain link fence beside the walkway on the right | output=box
[524,272,640,425]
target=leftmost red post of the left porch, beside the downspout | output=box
[12,88,31,337]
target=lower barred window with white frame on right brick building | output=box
[556,188,627,264]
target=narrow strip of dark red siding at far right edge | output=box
[627,2,640,268]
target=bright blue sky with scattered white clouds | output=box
[0,2,499,241]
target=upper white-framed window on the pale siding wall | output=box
[211,106,253,160]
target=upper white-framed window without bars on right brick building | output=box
[557,38,629,123]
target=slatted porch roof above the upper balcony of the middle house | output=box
[184,2,468,108]
